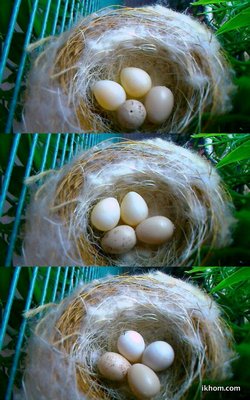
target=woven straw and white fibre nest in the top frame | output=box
[24,6,233,133]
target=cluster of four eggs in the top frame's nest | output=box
[92,67,174,129]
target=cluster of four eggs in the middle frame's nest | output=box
[90,192,174,254]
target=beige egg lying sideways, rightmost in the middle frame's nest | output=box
[135,216,175,244]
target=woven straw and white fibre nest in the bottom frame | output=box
[24,272,233,400]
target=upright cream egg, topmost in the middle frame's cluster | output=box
[121,192,148,226]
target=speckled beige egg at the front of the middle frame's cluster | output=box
[101,225,136,254]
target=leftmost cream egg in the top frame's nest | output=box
[92,80,126,111]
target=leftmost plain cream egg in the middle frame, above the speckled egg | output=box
[90,197,121,232]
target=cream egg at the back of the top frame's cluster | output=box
[120,67,152,98]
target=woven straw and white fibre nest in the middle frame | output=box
[24,139,233,266]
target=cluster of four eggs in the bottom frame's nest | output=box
[97,331,174,399]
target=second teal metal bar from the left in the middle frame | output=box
[6,133,38,266]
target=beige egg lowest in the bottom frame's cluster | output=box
[128,364,161,400]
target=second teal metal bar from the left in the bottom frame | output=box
[5,267,38,400]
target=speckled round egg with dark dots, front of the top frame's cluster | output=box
[117,100,146,129]
